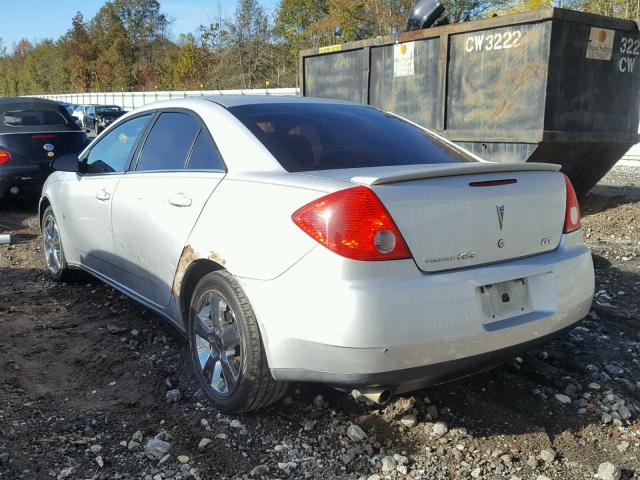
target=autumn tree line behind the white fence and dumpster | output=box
[0,0,640,95]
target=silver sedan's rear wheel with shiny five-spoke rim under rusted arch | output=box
[188,271,287,413]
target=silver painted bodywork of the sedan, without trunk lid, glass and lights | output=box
[43,99,594,386]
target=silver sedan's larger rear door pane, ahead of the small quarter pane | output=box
[136,112,200,171]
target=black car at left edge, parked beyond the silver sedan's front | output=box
[0,97,89,199]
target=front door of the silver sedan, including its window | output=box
[60,114,152,279]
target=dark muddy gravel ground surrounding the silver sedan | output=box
[0,168,640,480]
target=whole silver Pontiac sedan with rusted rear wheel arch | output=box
[40,96,594,412]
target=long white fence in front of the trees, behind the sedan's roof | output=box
[29,88,299,110]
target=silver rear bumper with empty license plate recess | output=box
[240,231,594,392]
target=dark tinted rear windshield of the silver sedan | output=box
[229,103,475,172]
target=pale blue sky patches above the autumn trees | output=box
[0,0,278,48]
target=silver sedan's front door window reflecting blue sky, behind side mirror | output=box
[81,114,151,174]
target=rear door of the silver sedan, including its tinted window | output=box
[113,111,225,307]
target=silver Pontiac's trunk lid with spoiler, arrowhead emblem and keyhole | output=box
[304,162,566,272]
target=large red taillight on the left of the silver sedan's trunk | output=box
[291,187,411,260]
